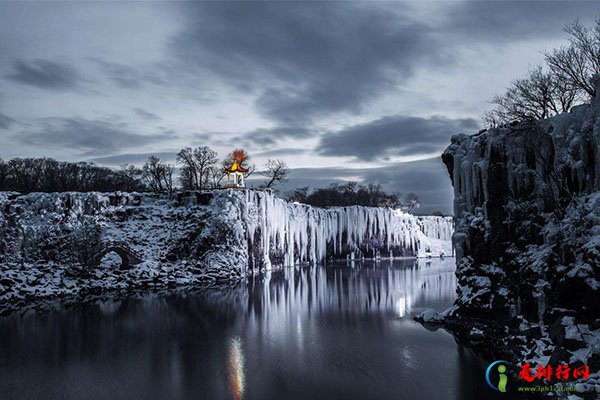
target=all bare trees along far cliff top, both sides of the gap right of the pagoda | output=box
[0,152,426,211]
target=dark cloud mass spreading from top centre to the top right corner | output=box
[170,1,598,125]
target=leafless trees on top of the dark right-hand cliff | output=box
[484,17,600,127]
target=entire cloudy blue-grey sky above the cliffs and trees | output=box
[0,1,600,213]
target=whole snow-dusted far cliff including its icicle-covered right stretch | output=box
[0,190,453,313]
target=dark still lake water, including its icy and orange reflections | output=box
[0,259,504,400]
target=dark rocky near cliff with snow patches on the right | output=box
[442,83,600,396]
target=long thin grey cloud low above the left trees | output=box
[15,118,175,156]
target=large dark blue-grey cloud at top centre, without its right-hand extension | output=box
[171,2,451,125]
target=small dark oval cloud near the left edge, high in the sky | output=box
[7,59,81,90]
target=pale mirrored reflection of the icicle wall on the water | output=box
[234,259,456,320]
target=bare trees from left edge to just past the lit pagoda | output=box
[0,146,289,193]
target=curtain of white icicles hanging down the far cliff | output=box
[225,190,453,268]
